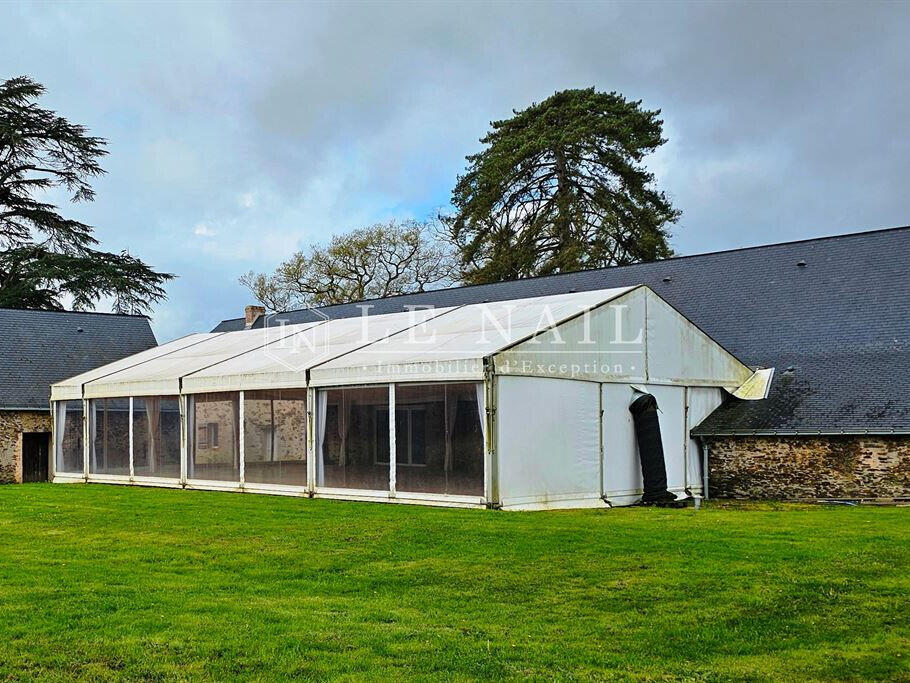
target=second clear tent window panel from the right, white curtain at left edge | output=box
[315,385,389,491]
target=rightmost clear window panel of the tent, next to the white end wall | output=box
[395,383,484,496]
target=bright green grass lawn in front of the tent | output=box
[0,484,910,681]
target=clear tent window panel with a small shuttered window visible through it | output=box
[187,392,240,483]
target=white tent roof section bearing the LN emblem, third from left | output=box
[183,308,452,393]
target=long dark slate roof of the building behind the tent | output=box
[213,227,910,434]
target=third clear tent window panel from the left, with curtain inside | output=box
[133,396,180,479]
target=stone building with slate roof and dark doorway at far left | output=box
[0,309,156,483]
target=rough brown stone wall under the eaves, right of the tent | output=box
[708,435,910,500]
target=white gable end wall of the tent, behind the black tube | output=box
[493,287,752,508]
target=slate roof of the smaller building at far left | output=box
[0,308,158,410]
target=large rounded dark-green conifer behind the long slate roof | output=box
[443,88,680,284]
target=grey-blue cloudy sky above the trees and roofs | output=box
[0,2,910,341]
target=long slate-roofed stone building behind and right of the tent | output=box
[213,227,910,499]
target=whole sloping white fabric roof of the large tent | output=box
[54,287,752,398]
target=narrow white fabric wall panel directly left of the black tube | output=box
[601,384,644,505]
